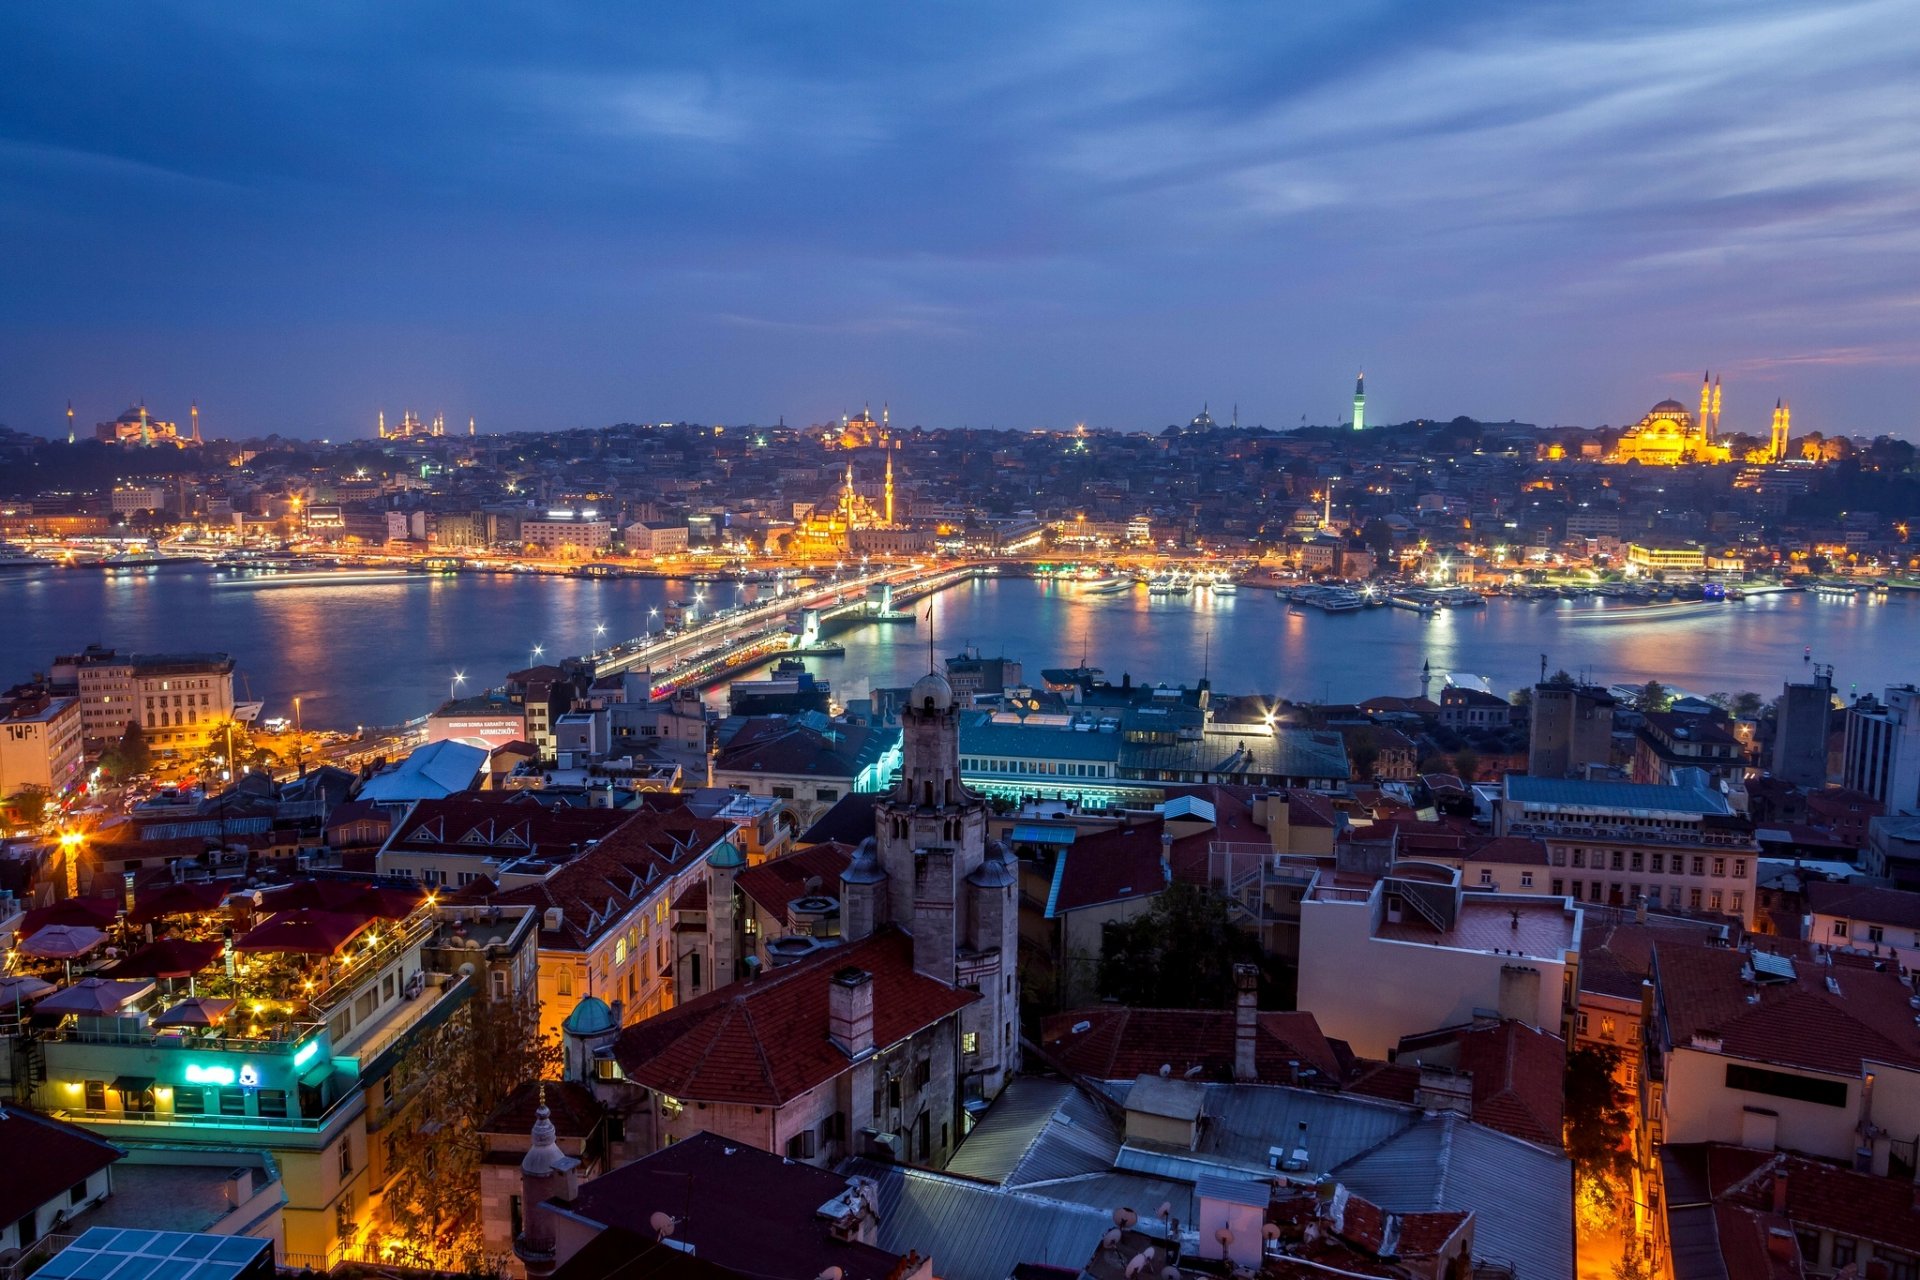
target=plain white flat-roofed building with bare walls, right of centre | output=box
[1298,856,1580,1057]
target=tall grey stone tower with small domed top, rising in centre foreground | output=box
[841,672,1020,1098]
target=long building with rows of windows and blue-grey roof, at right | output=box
[1494,773,1761,927]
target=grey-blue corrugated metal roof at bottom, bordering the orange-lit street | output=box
[1332,1111,1574,1280]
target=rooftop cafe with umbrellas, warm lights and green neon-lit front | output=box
[0,879,434,1123]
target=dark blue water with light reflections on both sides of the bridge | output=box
[0,566,1920,727]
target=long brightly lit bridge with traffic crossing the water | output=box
[584,562,983,699]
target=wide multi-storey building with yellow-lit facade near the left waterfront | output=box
[52,645,240,754]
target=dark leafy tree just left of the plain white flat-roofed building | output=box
[1100,883,1261,1009]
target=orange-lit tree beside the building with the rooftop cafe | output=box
[384,992,561,1274]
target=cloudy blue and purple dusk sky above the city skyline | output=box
[0,0,1920,439]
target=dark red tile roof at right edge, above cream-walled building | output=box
[1653,940,1920,1077]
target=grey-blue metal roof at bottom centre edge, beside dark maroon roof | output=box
[841,1159,1121,1280]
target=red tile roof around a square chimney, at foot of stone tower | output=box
[614,929,979,1107]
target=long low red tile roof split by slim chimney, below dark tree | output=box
[1041,1006,1348,1084]
